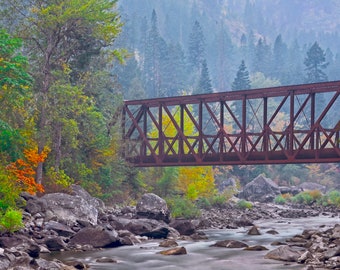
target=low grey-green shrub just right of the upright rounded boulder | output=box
[166,196,201,218]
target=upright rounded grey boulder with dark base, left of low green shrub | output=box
[136,193,170,223]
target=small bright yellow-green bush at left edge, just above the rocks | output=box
[0,208,24,233]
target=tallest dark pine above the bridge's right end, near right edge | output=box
[304,41,328,83]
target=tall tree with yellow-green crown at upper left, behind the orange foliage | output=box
[1,0,122,183]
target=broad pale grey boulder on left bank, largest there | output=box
[41,193,98,226]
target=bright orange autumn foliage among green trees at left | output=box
[7,147,50,194]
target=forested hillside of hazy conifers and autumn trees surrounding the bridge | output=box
[0,0,340,229]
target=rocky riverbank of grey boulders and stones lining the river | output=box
[0,186,340,269]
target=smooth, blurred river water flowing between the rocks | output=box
[44,216,340,270]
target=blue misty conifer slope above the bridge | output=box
[113,0,340,99]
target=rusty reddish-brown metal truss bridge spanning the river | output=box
[122,81,340,167]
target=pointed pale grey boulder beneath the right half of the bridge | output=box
[238,175,281,203]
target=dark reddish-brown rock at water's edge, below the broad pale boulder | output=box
[69,226,122,248]
